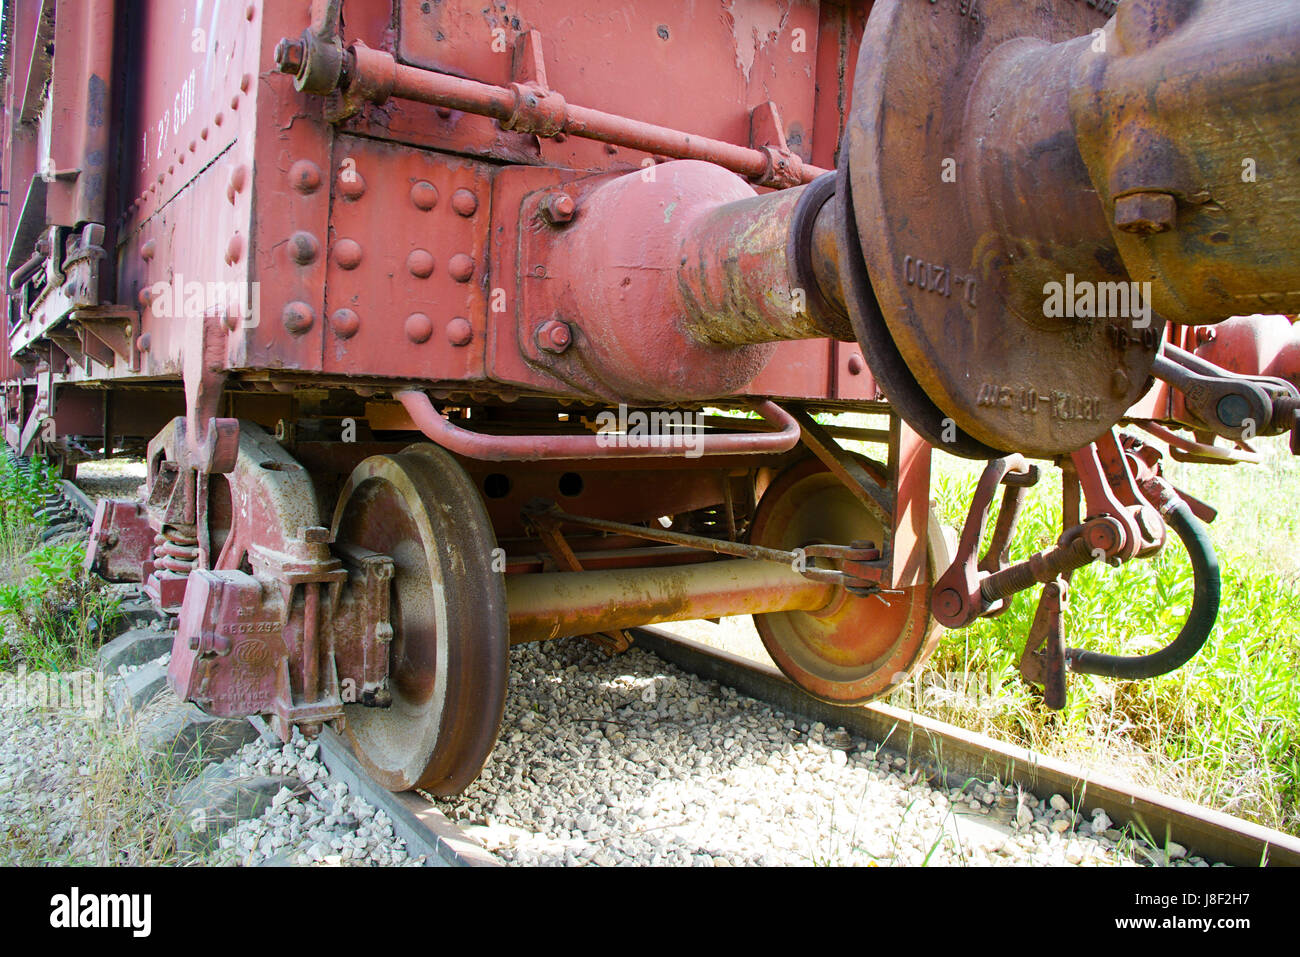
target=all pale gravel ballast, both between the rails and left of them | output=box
[0,624,1206,866]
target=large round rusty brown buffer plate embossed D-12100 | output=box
[845,0,1160,455]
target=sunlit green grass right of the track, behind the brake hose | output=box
[914,442,1300,833]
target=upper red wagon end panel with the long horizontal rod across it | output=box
[282,0,837,182]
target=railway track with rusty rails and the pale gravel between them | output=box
[12,460,1300,866]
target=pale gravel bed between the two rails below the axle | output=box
[438,641,1206,866]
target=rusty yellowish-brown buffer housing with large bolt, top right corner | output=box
[1070,0,1300,324]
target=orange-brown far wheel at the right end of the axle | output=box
[750,458,946,705]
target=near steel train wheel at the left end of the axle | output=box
[333,446,510,796]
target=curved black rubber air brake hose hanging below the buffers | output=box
[1065,498,1221,680]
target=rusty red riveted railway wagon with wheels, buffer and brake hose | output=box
[0,0,1300,794]
